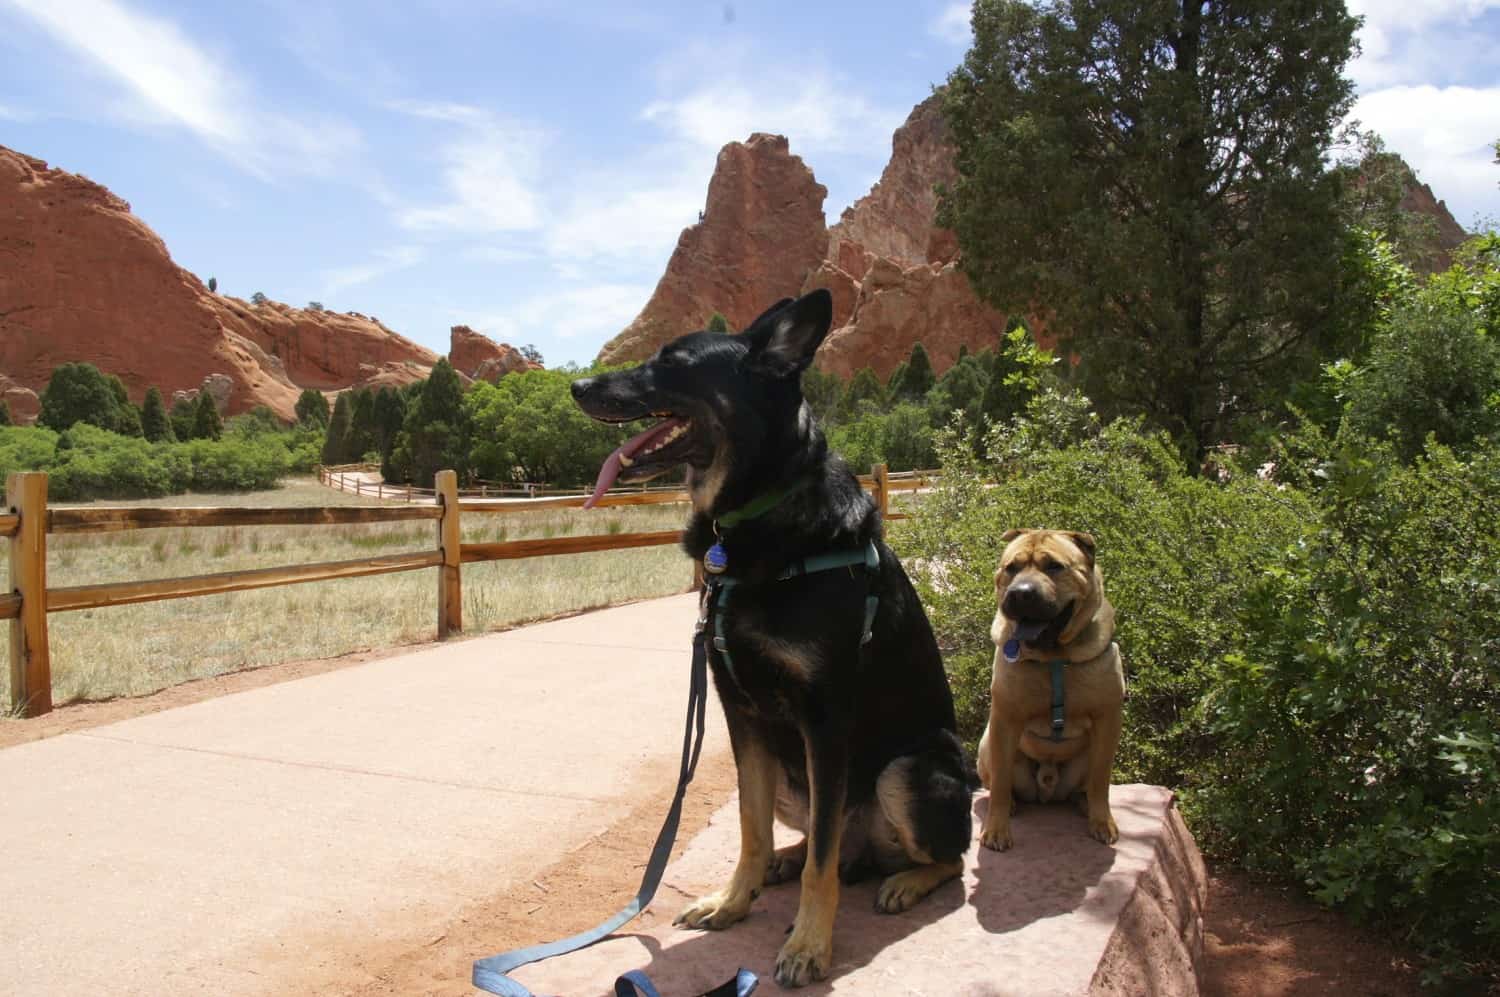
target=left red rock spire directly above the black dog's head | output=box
[599,133,828,363]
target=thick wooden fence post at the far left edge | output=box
[5,471,53,717]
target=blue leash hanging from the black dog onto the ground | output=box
[474,610,759,997]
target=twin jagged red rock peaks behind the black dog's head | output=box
[600,96,1005,378]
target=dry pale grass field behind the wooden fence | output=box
[0,478,692,703]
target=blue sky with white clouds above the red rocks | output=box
[0,0,1500,364]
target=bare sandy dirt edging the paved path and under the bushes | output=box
[0,648,1419,997]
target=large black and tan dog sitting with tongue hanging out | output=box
[573,291,971,987]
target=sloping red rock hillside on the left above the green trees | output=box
[0,147,527,420]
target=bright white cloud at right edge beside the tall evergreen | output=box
[1353,85,1500,228]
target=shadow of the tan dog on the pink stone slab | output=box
[969,793,1116,934]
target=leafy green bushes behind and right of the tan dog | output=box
[893,395,1500,985]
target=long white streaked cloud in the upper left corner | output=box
[0,0,360,178]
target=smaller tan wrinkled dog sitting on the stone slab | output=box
[978,529,1125,852]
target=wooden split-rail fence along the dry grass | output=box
[0,465,933,717]
